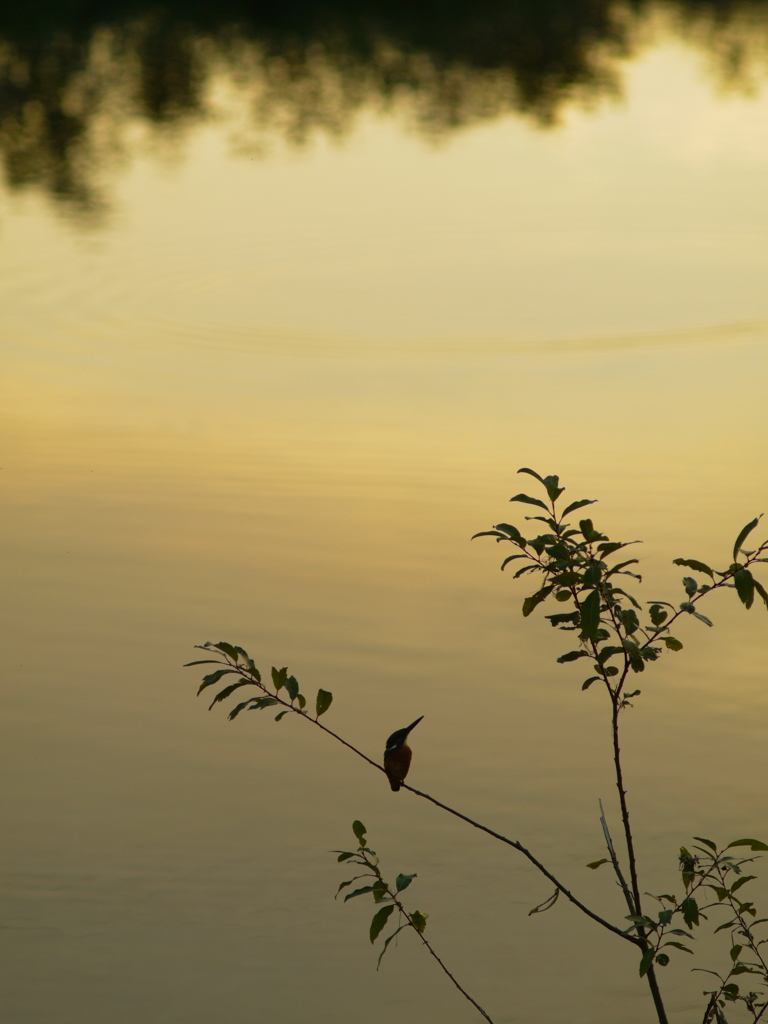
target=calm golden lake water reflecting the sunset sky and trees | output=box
[0,0,768,1024]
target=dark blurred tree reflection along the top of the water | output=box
[0,0,768,216]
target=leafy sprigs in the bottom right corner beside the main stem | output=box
[627,836,768,1021]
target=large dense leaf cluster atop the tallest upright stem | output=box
[475,468,768,708]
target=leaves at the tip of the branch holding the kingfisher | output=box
[184,640,333,722]
